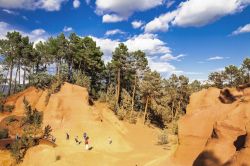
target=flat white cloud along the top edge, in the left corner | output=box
[0,0,68,11]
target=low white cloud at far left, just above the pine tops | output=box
[0,22,48,43]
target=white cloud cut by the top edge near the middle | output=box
[96,0,164,22]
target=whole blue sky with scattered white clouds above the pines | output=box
[0,0,250,80]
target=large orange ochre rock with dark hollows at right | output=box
[169,88,250,166]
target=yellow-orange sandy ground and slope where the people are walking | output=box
[0,83,175,166]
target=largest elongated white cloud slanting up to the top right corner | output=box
[145,0,250,32]
